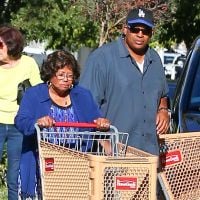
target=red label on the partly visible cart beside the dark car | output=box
[160,150,182,167]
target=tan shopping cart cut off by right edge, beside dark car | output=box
[159,132,200,200]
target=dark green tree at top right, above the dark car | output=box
[157,0,200,49]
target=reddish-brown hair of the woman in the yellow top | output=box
[0,25,24,60]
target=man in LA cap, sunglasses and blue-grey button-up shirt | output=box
[80,8,169,155]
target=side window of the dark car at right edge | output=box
[189,59,200,111]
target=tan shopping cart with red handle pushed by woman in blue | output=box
[35,122,158,200]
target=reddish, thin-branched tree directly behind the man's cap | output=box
[79,0,167,46]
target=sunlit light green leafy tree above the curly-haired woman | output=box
[11,0,97,51]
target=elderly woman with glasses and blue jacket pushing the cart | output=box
[15,50,110,196]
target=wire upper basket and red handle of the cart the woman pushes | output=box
[35,123,129,157]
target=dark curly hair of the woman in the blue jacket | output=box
[40,50,80,83]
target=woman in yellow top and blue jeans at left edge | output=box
[0,25,42,200]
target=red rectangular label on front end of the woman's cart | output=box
[115,176,137,190]
